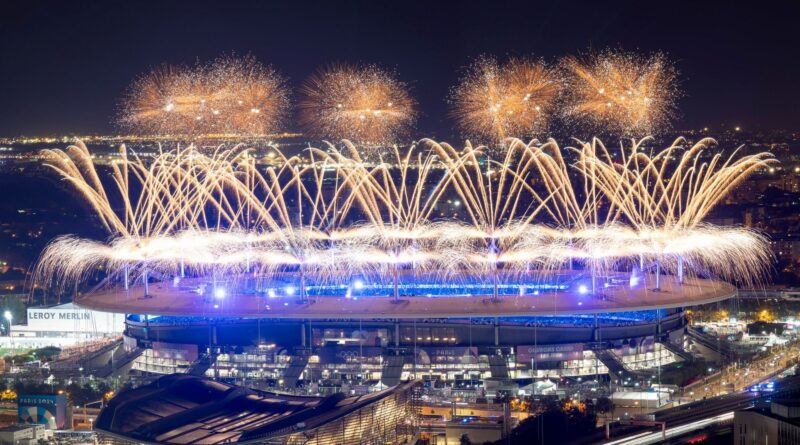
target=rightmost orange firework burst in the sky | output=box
[563,51,679,137]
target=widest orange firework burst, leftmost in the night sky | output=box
[118,57,289,137]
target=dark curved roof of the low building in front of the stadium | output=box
[95,374,412,444]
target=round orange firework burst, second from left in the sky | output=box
[300,65,416,145]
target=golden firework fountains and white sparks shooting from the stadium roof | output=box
[35,139,775,297]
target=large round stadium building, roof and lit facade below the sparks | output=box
[78,272,735,400]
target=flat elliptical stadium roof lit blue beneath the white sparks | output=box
[76,272,736,319]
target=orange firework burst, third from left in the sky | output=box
[451,57,562,142]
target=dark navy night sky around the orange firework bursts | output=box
[0,0,800,137]
